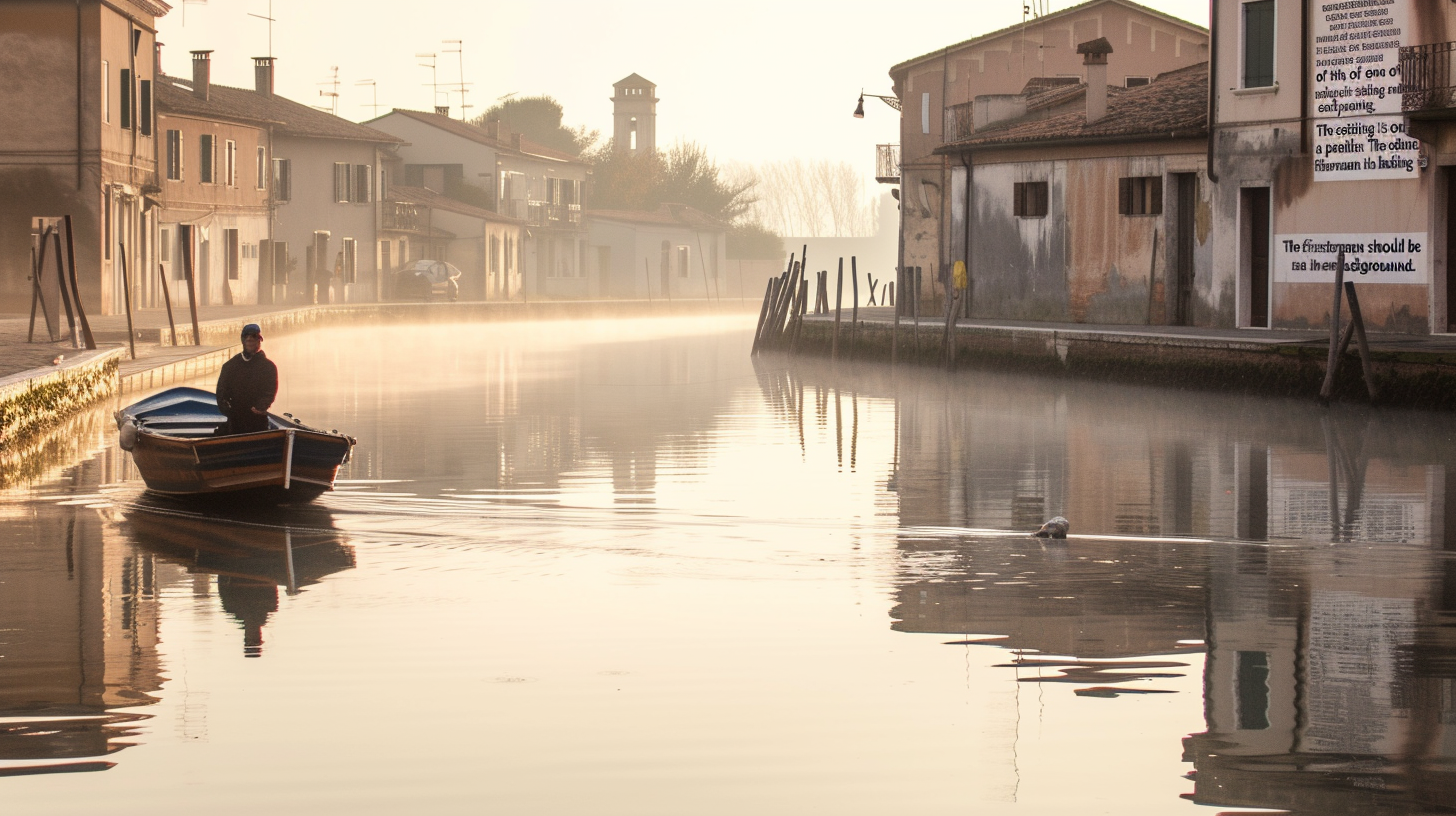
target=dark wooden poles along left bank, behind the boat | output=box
[26,216,202,360]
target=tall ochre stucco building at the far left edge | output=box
[0,0,170,313]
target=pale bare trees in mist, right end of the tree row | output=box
[725,159,879,238]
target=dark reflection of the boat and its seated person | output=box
[125,494,354,657]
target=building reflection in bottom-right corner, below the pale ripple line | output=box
[1187,539,1456,815]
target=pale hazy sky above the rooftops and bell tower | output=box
[159,0,1208,175]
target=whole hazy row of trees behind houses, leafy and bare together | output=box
[468,96,878,258]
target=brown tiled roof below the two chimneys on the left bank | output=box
[156,76,405,144]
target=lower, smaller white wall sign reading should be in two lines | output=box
[1274,232,1430,284]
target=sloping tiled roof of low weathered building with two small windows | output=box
[936,63,1208,153]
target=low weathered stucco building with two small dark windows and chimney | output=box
[938,55,1219,325]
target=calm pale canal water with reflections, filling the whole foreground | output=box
[0,316,1456,815]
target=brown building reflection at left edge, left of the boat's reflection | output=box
[0,452,181,772]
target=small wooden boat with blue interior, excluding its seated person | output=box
[116,388,354,503]
